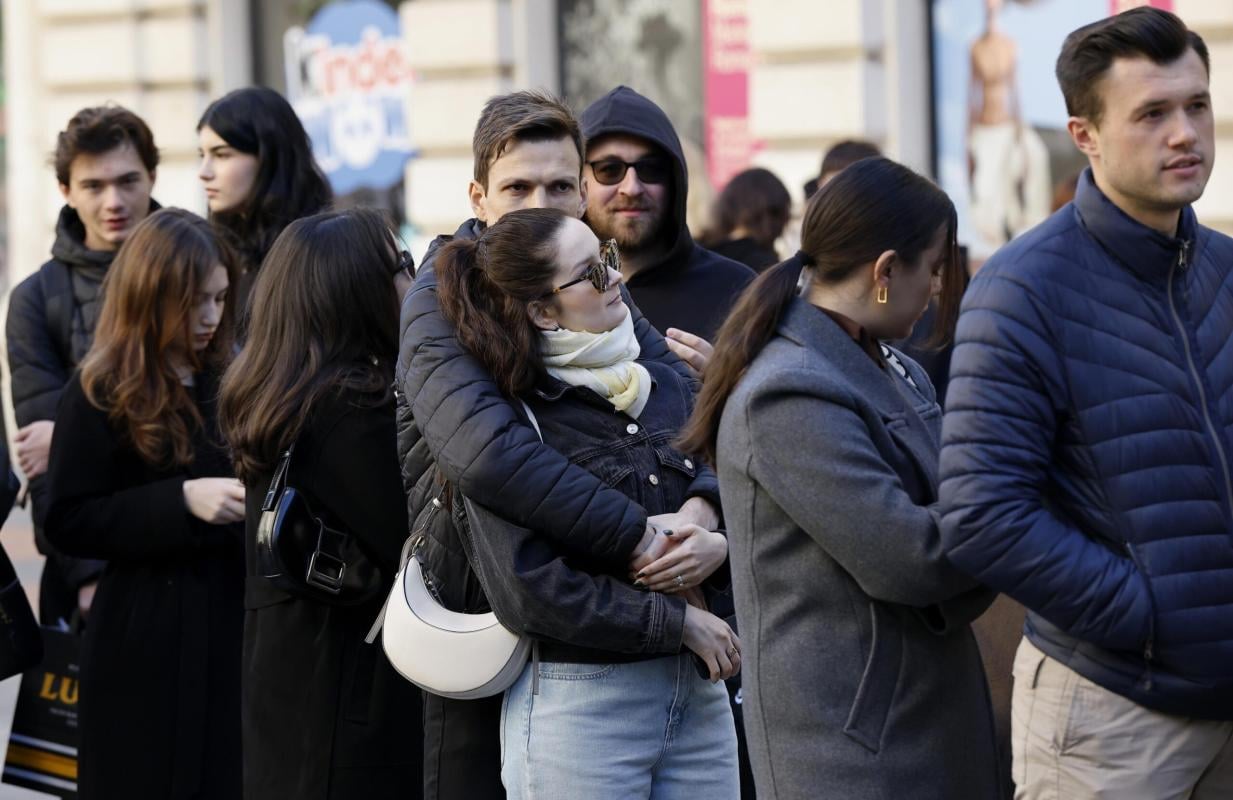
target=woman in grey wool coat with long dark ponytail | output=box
[681,158,1000,800]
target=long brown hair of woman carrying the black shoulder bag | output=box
[218,208,398,483]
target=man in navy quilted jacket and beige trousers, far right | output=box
[941,7,1233,800]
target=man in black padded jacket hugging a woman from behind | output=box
[396,91,719,800]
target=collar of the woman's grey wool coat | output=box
[779,297,924,417]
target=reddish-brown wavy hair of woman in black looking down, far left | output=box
[81,208,236,467]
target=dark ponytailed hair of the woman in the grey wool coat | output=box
[677,158,964,463]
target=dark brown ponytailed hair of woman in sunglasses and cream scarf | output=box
[434,208,581,397]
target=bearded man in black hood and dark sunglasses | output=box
[582,86,756,371]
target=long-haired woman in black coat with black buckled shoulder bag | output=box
[221,211,423,800]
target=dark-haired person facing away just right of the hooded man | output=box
[699,166,792,272]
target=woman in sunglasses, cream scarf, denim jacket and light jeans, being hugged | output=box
[436,208,741,800]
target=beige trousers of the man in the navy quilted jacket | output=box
[1011,639,1233,800]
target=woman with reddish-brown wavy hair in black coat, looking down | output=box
[47,208,244,800]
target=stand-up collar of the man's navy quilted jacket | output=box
[1074,168,1198,281]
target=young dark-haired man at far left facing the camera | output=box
[6,106,158,625]
